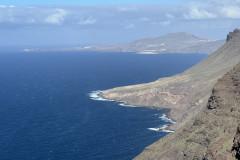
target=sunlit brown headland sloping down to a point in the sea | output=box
[101,30,240,130]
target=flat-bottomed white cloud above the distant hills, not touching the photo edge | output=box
[183,8,217,20]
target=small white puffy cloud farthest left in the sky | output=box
[45,9,67,24]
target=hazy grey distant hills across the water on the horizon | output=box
[90,32,225,54]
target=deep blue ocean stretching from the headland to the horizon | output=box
[0,52,206,160]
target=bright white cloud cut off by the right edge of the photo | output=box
[221,6,240,19]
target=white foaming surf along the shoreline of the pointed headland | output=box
[88,90,176,133]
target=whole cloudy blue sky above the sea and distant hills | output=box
[0,0,240,46]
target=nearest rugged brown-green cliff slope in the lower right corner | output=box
[136,60,240,160]
